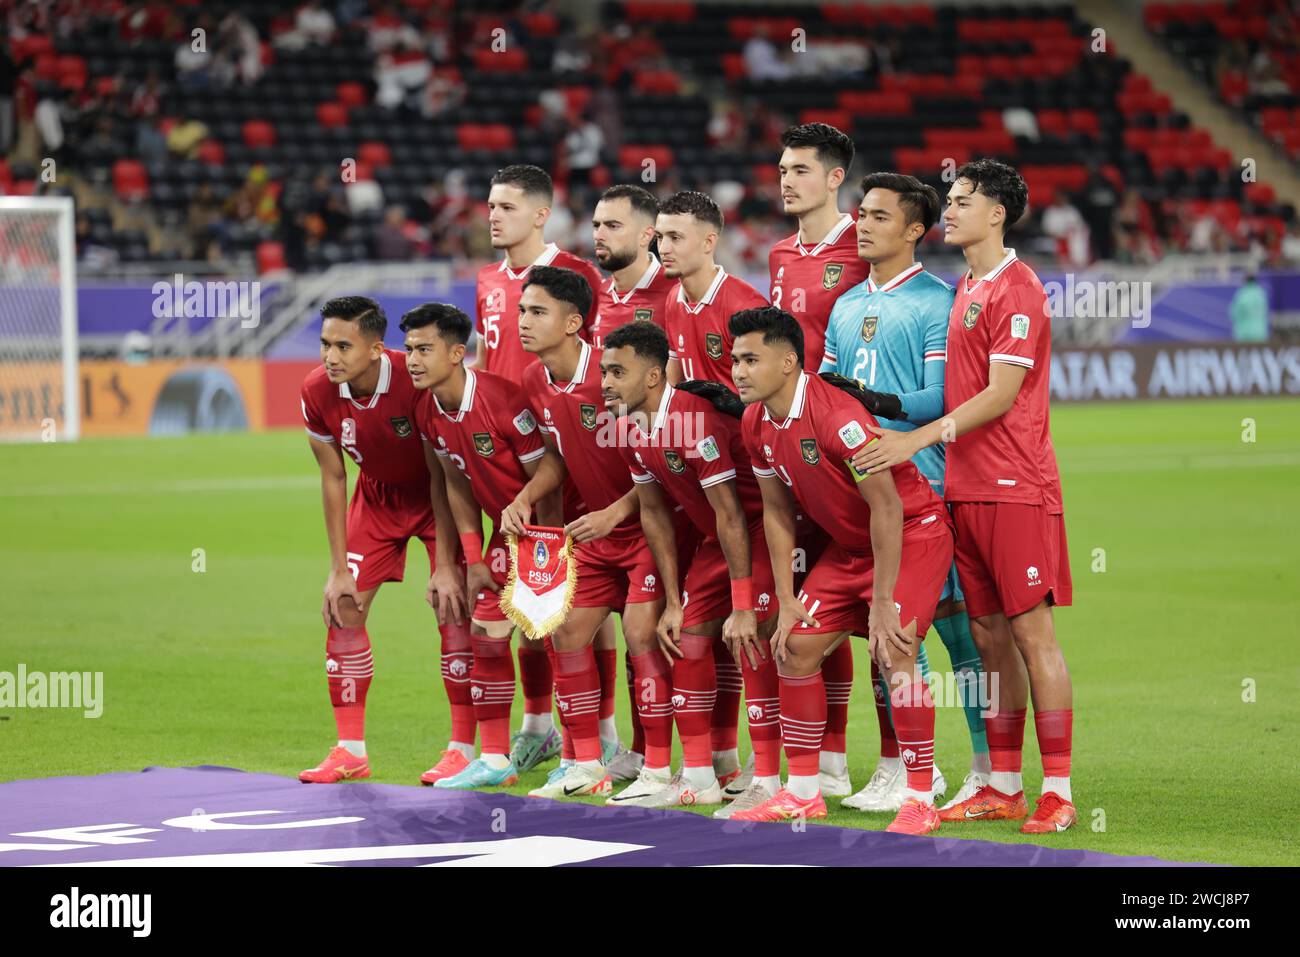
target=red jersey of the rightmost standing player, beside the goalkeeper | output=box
[944,250,1062,511]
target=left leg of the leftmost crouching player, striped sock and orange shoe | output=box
[298,585,380,784]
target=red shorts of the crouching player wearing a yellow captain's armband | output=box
[796,525,953,637]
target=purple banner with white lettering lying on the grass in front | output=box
[0,767,1190,867]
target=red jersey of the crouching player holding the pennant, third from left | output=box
[520,342,640,529]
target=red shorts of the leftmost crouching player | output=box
[347,475,434,592]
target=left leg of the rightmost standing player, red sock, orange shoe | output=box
[939,609,1030,822]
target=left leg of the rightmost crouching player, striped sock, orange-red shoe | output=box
[731,632,845,820]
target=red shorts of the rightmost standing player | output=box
[952,502,1073,618]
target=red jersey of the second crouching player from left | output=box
[420,369,546,525]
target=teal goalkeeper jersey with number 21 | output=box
[819,263,956,494]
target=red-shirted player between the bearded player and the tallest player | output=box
[655,190,767,389]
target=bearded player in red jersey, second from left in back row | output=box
[592,186,672,348]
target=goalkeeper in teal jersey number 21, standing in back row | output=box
[820,173,991,810]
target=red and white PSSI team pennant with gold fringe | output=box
[501,525,577,638]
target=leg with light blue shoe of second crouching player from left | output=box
[433,619,519,789]
